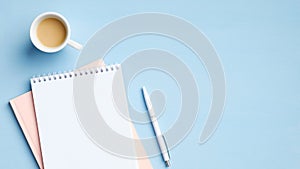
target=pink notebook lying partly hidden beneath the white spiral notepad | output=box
[10,60,152,169]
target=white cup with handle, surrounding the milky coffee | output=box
[30,12,82,53]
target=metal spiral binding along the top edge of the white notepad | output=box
[30,64,120,83]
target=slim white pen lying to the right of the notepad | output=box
[142,86,171,167]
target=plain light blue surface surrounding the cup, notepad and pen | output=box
[0,0,300,169]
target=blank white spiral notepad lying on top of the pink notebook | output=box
[31,65,137,169]
